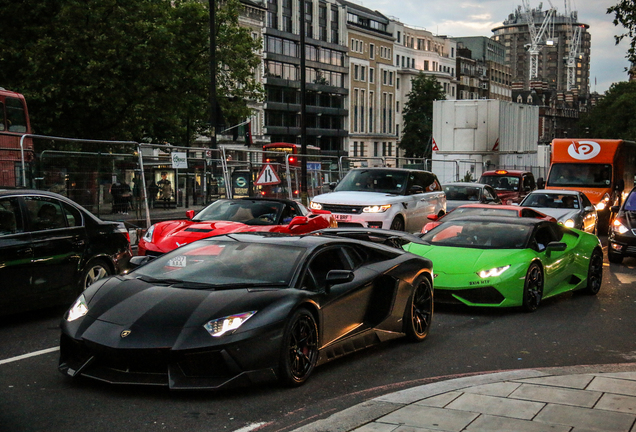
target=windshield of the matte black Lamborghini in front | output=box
[130,240,305,287]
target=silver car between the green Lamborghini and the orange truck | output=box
[520,189,598,235]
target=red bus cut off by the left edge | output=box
[0,87,33,187]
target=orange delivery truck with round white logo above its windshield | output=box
[538,138,636,228]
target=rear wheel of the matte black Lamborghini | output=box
[404,277,433,342]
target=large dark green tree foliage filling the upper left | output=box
[0,0,262,145]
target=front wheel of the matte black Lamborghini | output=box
[280,309,318,387]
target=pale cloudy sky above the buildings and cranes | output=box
[350,0,629,93]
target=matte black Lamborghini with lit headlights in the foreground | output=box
[59,233,433,389]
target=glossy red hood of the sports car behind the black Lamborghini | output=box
[153,220,286,253]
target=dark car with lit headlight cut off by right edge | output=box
[607,188,636,264]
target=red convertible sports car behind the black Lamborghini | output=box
[137,198,338,255]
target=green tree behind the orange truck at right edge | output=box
[579,81,636,140]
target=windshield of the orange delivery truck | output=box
[547,163,612,188]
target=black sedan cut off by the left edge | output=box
[0,189,132,315]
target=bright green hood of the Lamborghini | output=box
[405,243,523,275]
